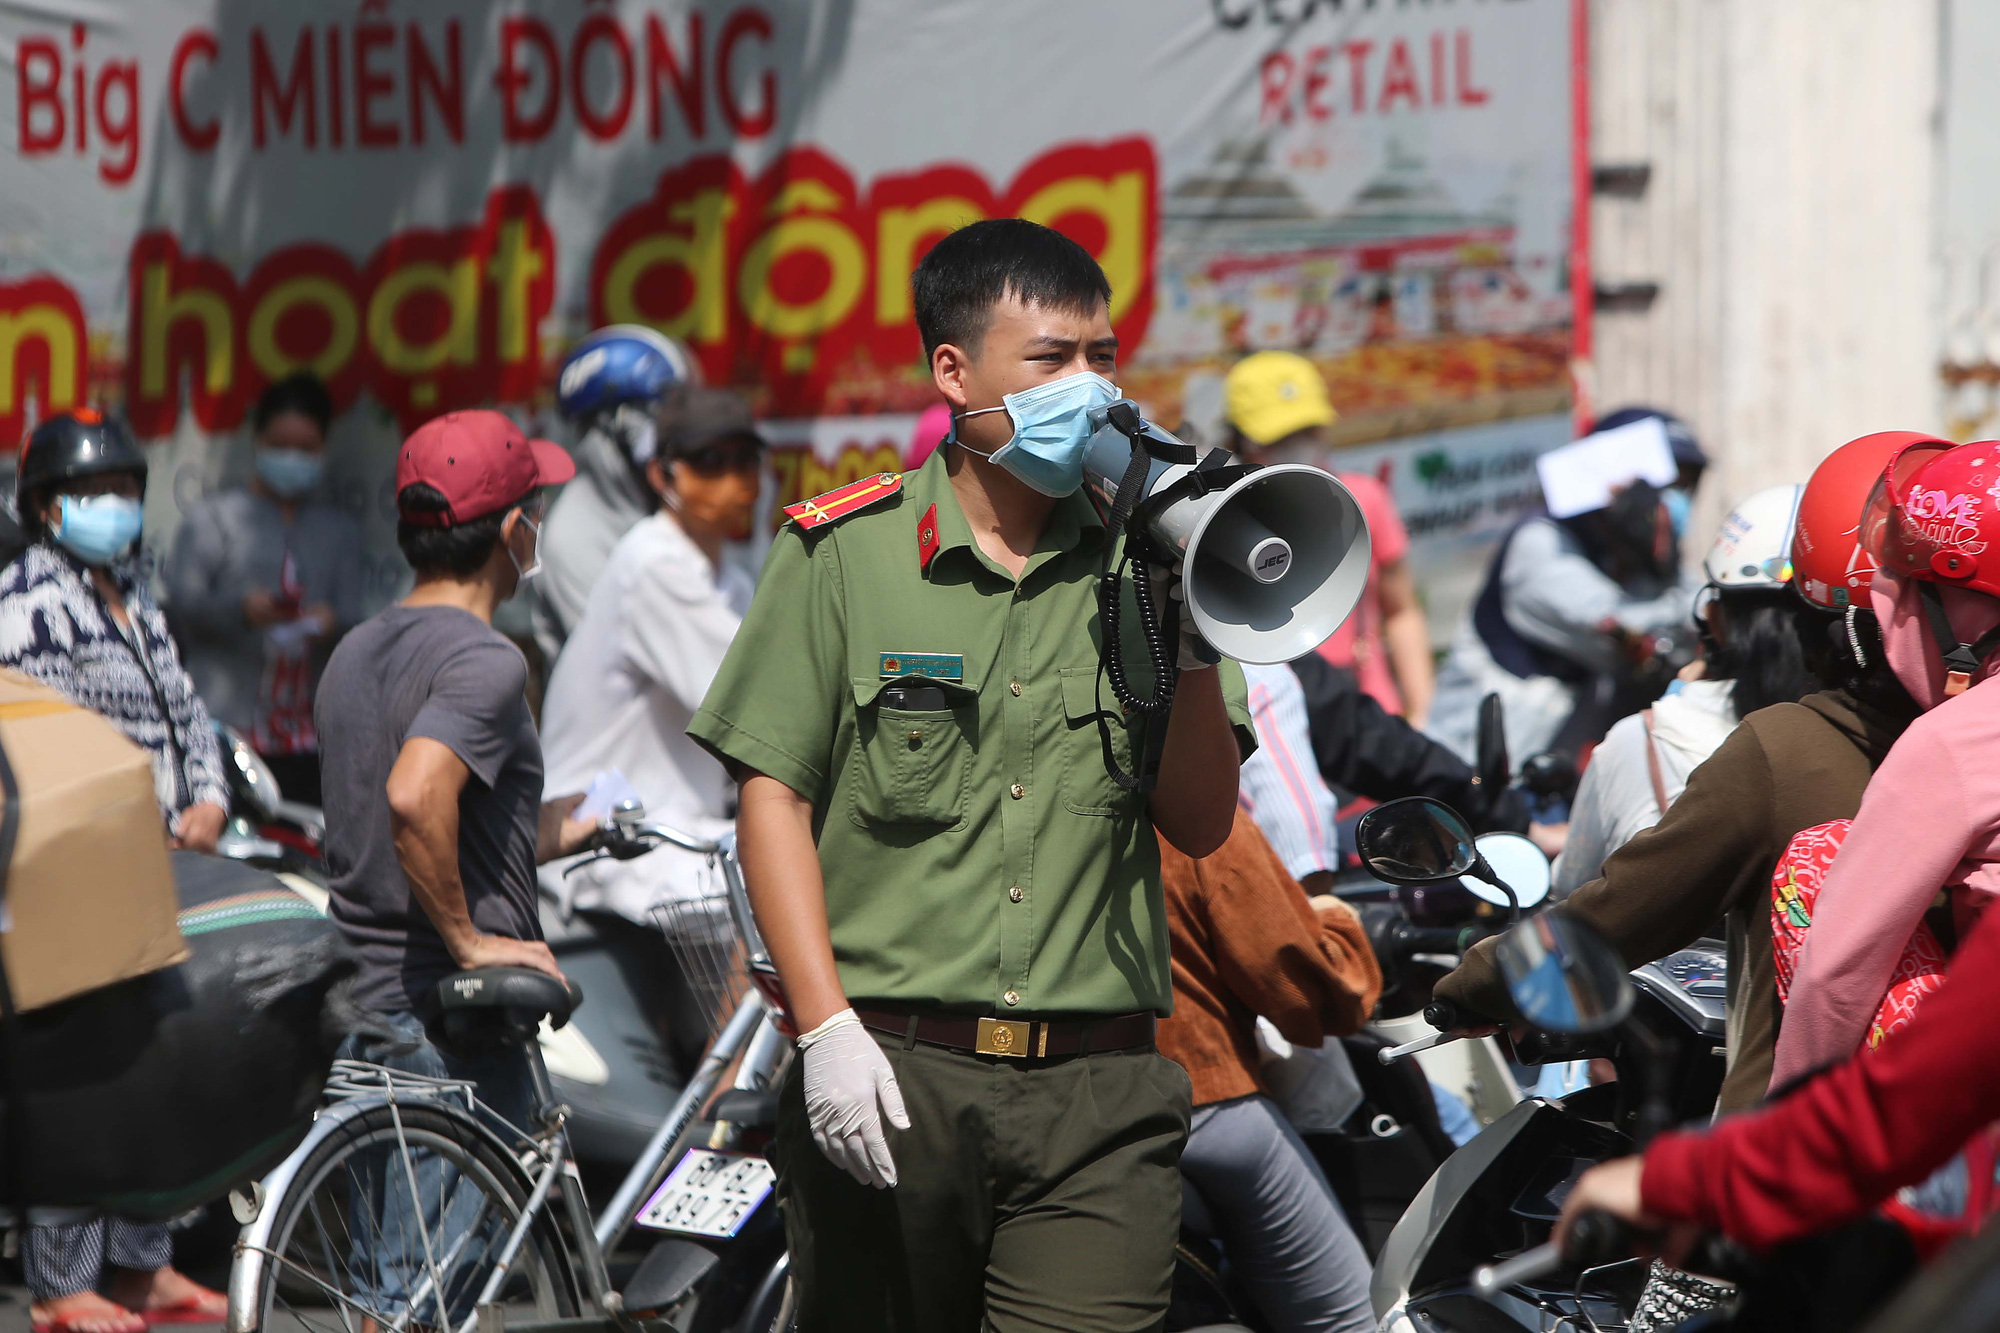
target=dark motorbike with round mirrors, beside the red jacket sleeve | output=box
[1364,801,1726,1333]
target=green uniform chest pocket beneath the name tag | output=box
[848,679,978,831]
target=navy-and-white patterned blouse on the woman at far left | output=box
[0,542,230,829]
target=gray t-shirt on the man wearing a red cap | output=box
[314,604,542,1015]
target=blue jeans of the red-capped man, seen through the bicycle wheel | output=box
[340,1013,534,1325]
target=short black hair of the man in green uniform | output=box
[910,218,1112,356]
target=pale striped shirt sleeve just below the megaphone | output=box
[1236,662,1340,879]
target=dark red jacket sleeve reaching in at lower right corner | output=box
[1640,892,2000,1249]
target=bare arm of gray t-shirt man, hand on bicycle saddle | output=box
[388,737,562,979]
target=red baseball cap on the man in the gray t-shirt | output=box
[396,410,576,528]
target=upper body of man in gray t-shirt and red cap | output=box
[314,412,590,1035]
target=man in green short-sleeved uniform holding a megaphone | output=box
[688,218,1254,1333]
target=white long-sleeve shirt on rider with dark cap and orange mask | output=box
[542,512,756,925]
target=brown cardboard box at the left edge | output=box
[0,671,188,1009]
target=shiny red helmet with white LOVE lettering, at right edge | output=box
[1862,440,2000,596]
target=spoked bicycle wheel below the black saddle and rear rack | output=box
[258,1103,576,1333]
